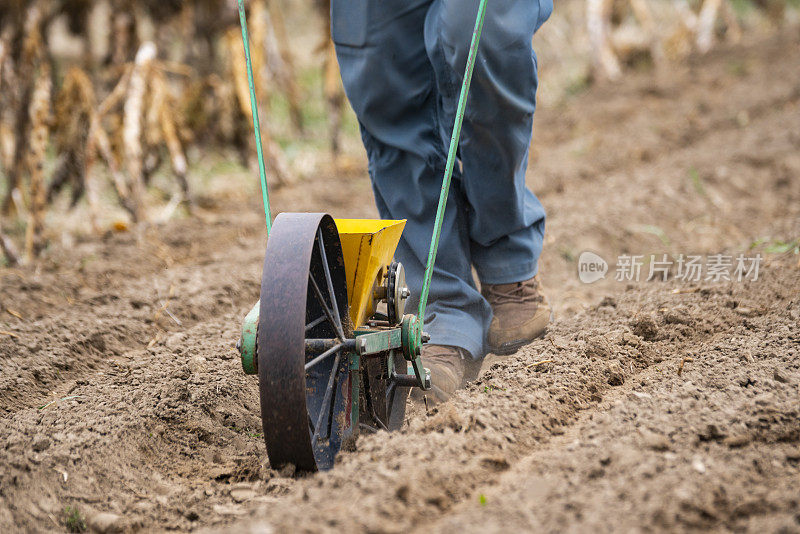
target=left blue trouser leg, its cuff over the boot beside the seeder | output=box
[332,0,491,357]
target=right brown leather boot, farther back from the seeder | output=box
[481,276,552,355]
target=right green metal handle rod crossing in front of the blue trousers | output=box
[417,0,486,324]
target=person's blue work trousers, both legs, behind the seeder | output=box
[331,0,553,358]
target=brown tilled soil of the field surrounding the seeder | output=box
[0,32,800,532]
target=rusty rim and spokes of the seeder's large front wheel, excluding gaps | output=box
[257,213,352,471]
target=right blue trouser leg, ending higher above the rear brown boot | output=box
[425,0,553,284]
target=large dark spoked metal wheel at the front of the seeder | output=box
[257,213,359,471]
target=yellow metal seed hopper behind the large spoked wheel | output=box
[336,219,406,328]
